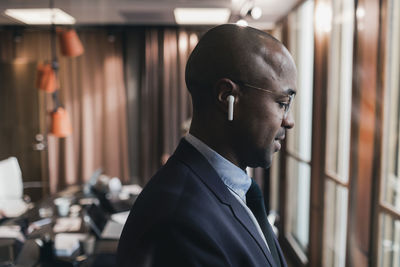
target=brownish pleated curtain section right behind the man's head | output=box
[137,28,198,185]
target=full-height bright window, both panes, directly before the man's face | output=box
[285,1,314,259]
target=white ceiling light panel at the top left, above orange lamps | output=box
[4,8,75,25]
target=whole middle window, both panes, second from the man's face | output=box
[321,0,354,267]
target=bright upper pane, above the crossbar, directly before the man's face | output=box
[287,1,314,162]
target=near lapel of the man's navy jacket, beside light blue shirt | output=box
[174,139,282,266]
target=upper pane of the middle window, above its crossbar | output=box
[326,0,354,182]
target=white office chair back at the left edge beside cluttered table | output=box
[0,157,28,217]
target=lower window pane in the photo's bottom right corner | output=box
[379,214,400,267]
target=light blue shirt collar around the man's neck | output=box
[185,133,251,202]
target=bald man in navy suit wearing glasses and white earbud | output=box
[117,24,296,267]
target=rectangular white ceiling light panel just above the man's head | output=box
[174,8,231,25]
